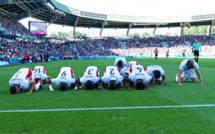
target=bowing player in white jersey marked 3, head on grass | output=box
[80,66,100,90]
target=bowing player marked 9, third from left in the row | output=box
[48,67,77,91]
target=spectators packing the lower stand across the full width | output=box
[0,35,215,62]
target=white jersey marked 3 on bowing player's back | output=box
[80,66,100,84]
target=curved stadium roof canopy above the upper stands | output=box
[0,0,215,28]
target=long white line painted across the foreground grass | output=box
[0,104,215,113]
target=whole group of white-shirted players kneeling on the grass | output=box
[9,56,203,94]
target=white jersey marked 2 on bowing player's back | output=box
[102,66,123,84]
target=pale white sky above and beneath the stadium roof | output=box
[20,0,215,35]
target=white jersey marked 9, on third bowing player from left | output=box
[51,67,75,86]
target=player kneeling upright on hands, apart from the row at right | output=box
[178,59,204,85]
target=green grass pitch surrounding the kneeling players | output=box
[0,58,215,134]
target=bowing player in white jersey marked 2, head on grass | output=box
[100,66,123,90]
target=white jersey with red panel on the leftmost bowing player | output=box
[9,68,34,90]
